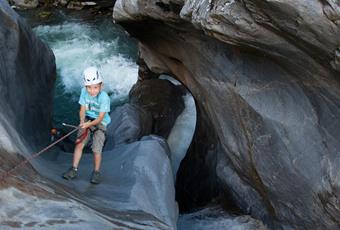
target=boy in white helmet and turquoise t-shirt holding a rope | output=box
[63,67,111,184]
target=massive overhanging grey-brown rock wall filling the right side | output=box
[113,0,340,229]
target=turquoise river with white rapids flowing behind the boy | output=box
[34,13,138,127]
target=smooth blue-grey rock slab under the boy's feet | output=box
[33,136,178,229]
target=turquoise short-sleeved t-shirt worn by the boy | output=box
[79,88,111,126]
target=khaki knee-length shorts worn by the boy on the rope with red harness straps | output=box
[77,119,106,154]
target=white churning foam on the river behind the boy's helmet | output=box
[35,22,138,97]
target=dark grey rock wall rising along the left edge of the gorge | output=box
[0,0,55,155]
